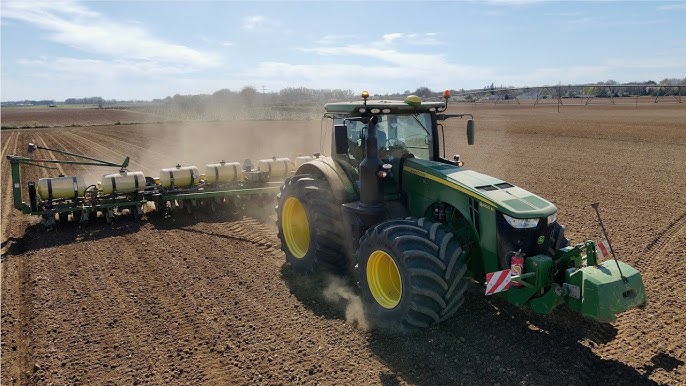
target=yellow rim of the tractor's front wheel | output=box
[367,250,403,309]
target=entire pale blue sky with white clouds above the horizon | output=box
[0,0,686,101]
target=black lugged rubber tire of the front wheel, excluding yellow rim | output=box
[356,218,468,332]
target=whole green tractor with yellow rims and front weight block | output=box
[276,91,646,332]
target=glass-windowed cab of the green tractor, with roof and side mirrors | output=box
[325,92,473,200]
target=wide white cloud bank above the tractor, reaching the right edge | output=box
[276,28,686,93]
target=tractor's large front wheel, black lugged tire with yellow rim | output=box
[356,218,468,332]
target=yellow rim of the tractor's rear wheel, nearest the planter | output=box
[281,197,310,259]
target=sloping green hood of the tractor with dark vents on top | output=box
[403,158,557,218]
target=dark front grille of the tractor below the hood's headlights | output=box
[496,213,553,269]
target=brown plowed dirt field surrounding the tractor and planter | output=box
[1,103,686,385]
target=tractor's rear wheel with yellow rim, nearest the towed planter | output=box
[276,175,348,273]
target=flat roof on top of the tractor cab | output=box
[324,100,445,114]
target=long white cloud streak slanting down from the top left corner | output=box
[2,1,221,70]
